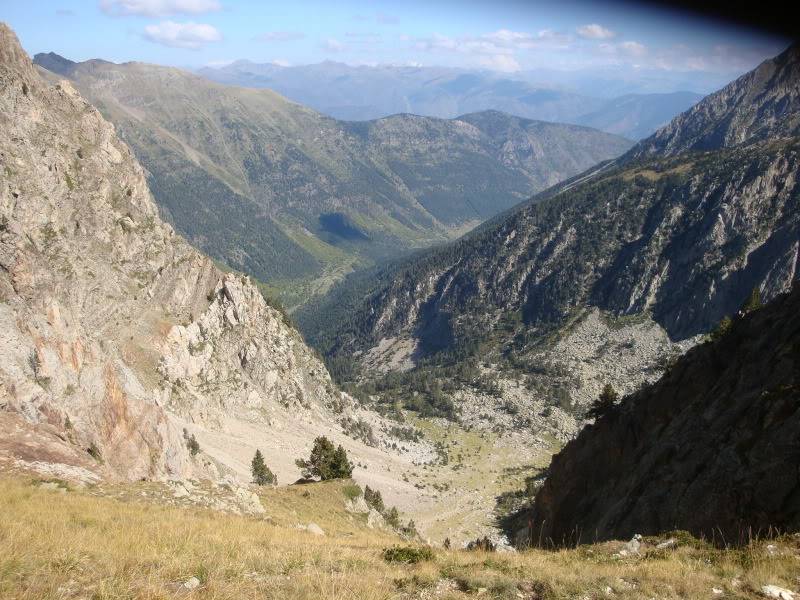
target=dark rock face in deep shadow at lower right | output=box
[517,286,800,545]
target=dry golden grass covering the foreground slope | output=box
[0,477,800,600]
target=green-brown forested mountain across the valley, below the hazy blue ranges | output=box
[36,54,630,304]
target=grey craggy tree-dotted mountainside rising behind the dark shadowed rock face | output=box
[300,43,800,422]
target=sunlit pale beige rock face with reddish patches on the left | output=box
[0,24,338,479]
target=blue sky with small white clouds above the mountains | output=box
[0,0,788,77]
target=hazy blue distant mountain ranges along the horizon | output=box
[198,60,700,140]
